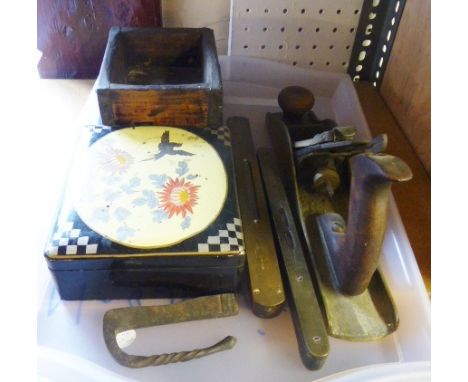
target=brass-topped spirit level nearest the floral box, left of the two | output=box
[227,117,285,318]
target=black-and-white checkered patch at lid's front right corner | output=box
[198,218,244,253]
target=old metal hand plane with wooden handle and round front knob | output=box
[266,86,412,341]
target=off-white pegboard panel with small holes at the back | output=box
[229,0,364,73]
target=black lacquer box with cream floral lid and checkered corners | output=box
[45,126,245,300]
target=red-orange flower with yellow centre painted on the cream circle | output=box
[159,178,200,218]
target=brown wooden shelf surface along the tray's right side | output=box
[355,82,431,293]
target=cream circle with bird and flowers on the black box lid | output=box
[73,126,228,248]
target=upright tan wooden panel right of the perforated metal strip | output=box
[380,0,431,173]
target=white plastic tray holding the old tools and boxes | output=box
[38,57,431,382]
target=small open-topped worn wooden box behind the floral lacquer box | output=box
[97,27,223,127]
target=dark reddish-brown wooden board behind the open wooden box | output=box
[37,0,161,78]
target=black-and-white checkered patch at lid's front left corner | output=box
[46,221,98,256]
